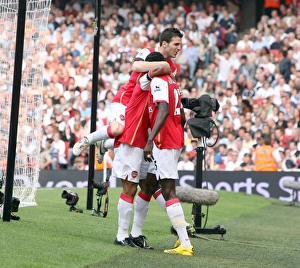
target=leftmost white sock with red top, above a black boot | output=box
[117,193,133,241]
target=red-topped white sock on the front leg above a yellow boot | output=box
[166,198,191,248]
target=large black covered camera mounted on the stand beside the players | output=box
[181,94,220,139]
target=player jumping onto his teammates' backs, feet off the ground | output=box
[73,28,182,163]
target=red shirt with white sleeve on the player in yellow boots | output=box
[148,75,184,149]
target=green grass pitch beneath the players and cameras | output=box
[0,188,300,268]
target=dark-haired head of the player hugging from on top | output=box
[159,28,183,58]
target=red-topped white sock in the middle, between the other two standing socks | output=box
[131,192,151,237]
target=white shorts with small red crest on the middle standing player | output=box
[112,143,156,183]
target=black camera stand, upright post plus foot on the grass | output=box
[192,137,226,240]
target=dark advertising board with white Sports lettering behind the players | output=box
[38,170,300,202]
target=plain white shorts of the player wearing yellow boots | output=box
[153,144,181,180]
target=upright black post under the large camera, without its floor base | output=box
[193,138,204,228]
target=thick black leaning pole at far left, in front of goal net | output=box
[3,0,26,221]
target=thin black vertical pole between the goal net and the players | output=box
[86,0,101,210]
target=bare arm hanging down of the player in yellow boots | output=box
[144,102,170,162]
